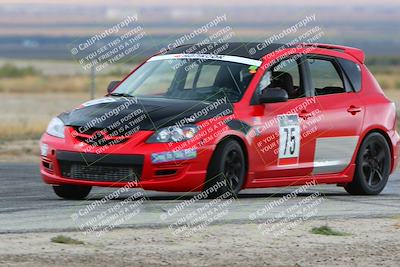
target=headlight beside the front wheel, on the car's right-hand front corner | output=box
[147,125,200,143]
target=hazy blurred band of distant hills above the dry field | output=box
[0,0,400,58]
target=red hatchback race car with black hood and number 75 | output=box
[40,43,400,199]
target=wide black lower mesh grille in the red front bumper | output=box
[57,151,143,182]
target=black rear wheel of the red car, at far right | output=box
[344,133,391,195]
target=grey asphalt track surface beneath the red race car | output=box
[0,163,400,233]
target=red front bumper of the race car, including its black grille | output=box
[40,132,215,192]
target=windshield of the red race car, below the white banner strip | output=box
[112,58,255,102]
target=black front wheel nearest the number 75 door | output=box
[203,139,246,198]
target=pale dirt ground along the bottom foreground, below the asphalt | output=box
[0,217,400,267]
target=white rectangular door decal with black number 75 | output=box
[278,114,301,165]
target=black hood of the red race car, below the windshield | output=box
[60,97,233,133]
